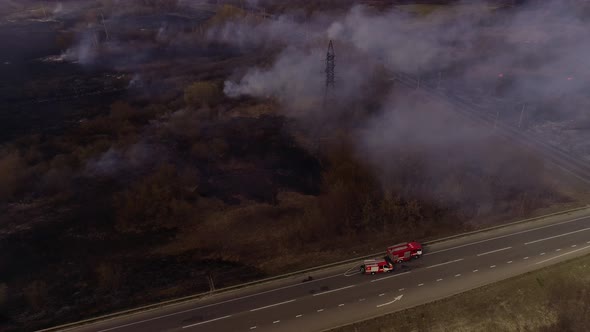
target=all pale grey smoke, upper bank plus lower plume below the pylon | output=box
[209,1,590,200]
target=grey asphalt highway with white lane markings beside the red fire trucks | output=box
[65,209,590,332]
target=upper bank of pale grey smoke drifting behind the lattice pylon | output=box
[219,1,590,120]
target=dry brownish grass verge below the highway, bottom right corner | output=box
[330,255,590,332]
